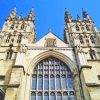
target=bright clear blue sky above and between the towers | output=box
[0,0,100,39]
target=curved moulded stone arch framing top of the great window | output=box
[27,51,77,73]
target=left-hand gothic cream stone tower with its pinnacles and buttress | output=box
[0,8,36,100]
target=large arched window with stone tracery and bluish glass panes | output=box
[31,57,75,100]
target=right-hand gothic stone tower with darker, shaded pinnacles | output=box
[64,9,100,100]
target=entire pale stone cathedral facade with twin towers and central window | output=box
[0,8,100,100]
